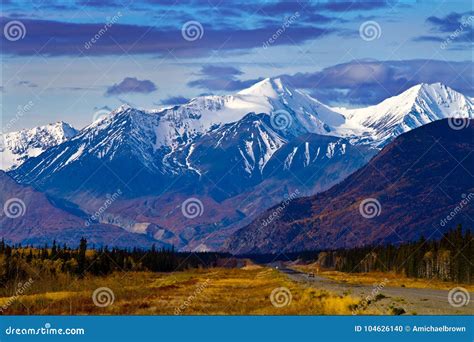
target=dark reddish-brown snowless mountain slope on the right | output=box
[225,120,474,253]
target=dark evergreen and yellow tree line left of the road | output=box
[0,238,229,287]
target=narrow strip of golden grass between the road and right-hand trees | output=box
[294,264,474,291]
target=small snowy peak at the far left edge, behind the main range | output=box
[0,121,77,170]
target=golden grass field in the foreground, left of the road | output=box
[0,265,380,315]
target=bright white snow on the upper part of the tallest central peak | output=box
[150,78,344,145]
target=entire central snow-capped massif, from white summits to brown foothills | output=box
[6,78,473,249]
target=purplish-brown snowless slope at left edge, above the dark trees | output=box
[0,171,165,247]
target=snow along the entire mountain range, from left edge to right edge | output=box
[8,78,474,182]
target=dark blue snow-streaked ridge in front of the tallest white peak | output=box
[177,113,375,200]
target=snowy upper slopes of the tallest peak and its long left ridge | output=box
[8,78,344,192]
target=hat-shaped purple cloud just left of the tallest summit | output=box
[188,65,262,91]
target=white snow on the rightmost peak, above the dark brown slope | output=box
[337,83,474,147]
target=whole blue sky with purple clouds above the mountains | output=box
[0,0,474,132]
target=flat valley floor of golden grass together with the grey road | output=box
[0,263,474,315]
